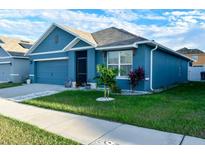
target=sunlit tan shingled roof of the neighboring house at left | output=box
[0,36,33,56]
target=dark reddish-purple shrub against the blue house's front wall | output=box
[128,67,144,92]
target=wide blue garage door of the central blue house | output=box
[35,58,68,85]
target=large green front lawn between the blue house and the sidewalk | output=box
[24,83,205,138]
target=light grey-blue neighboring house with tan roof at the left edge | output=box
[0,36,32,82]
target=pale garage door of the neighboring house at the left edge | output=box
[0,63,11,82]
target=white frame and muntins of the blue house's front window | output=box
[107,50,133,77]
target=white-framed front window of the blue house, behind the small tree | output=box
[107,50,132,77]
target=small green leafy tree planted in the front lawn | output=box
[96,65,118,97]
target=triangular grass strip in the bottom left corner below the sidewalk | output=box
[0,115,77,145]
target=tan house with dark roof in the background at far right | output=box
[177,47,205,66]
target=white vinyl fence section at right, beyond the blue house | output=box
[188,67,205,81]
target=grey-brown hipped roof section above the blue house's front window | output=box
[92,27,147,47]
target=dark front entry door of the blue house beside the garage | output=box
[76,51,87,86]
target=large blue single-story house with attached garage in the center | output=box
[27,24,191,91]
